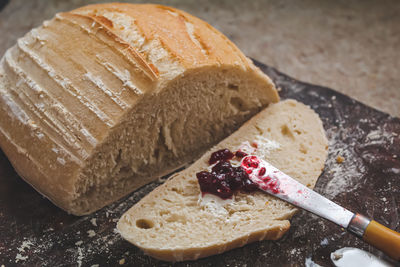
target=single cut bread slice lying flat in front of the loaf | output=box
[117,100,328,261]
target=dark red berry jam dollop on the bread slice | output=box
[196,149,258,199]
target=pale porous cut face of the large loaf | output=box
[73,68,278,216]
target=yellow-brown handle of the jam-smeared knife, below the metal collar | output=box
[363,220,400,260]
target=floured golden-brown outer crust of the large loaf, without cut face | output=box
[0,3,279,215]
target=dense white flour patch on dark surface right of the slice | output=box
[321,118,400,199]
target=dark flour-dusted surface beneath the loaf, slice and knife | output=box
[0,61,400,266]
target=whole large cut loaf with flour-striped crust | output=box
[0,3,279,215]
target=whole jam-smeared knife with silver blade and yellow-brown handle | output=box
[241,155,400,260]
